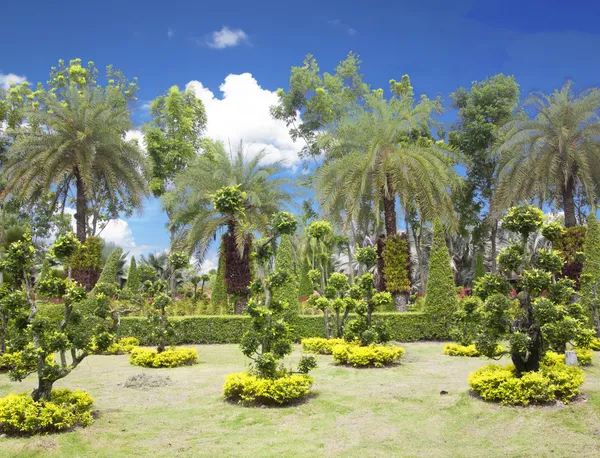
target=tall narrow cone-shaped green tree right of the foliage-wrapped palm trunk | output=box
[425,220,458,337]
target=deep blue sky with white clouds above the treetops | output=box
[0,0,600,270]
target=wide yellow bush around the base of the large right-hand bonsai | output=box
[469,355,584,406]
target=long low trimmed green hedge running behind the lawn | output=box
[121,312,448,345]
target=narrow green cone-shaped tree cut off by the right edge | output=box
[581,212,600,337]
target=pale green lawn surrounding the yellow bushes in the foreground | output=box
[0,343,600,458]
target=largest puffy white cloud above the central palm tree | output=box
[186,73,301,167]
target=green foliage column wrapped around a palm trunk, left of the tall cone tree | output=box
[381,234,410,293]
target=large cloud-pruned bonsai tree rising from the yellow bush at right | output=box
[474,205,593,376]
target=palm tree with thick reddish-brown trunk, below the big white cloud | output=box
[171,142,291,313]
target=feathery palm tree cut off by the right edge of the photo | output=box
[496,81,600,227]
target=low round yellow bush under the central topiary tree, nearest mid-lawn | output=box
[223,372,313,405]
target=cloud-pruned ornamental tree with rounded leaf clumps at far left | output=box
[0,232,111,401]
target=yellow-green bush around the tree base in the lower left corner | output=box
[0,389,94,436]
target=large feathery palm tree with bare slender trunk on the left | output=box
[5,85,146,242]
